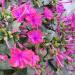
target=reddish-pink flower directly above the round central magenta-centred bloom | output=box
[26,13,42,28]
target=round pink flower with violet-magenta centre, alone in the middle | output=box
[28,30,43,44]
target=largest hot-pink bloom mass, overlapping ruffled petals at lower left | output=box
[9,48,40,69]
